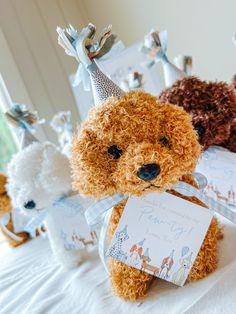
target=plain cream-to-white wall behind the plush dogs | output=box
[0,0,236,139]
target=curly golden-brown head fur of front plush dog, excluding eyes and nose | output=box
[71,91,200,198]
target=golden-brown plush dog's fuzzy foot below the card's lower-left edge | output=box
[110,259,153,301]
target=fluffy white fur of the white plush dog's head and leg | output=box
[7,142,87,268]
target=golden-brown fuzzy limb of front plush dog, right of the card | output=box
[188,218,223,281]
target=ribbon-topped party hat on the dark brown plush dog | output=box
[141,30,186,87]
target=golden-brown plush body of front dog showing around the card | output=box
[108,175,223,301]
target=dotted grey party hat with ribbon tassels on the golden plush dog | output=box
[57,23,124,105]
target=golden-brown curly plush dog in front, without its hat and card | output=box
[71,91,222,301]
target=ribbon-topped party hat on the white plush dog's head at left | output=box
[5,103,44,149]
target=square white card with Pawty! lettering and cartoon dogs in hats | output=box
[107,192,213,286]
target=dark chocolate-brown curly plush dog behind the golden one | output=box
[159,76,236,152]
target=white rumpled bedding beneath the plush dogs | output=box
[0,216,236,314]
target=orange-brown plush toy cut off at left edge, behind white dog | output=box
[0,173,29,247]
